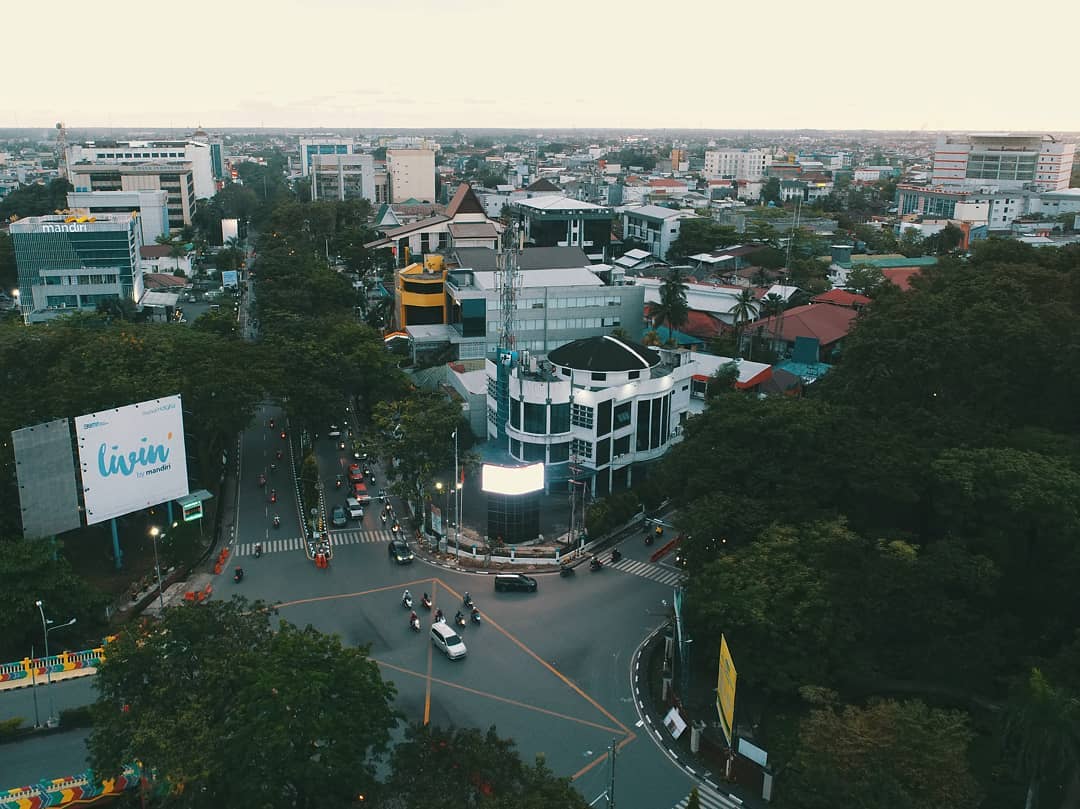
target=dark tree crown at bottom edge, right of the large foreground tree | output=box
[379,725,588,809]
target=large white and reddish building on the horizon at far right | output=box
[930,133,1076,191]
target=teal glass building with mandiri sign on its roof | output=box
[10,214,143,323]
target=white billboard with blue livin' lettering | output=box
[75,394,188,525]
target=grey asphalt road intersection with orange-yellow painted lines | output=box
[0,407,691,809]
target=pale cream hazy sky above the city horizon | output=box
[8,0,1080,132]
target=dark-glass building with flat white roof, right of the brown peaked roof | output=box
[512,197,615,262]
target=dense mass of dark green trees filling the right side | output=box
[660,240,1080,807]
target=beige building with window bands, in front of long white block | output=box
[68,163,197,230]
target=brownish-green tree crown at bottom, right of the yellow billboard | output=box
[783,700,980,809]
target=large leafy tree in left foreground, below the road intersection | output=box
[87,598,396,809]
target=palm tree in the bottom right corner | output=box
[1003,669,1080,809]
